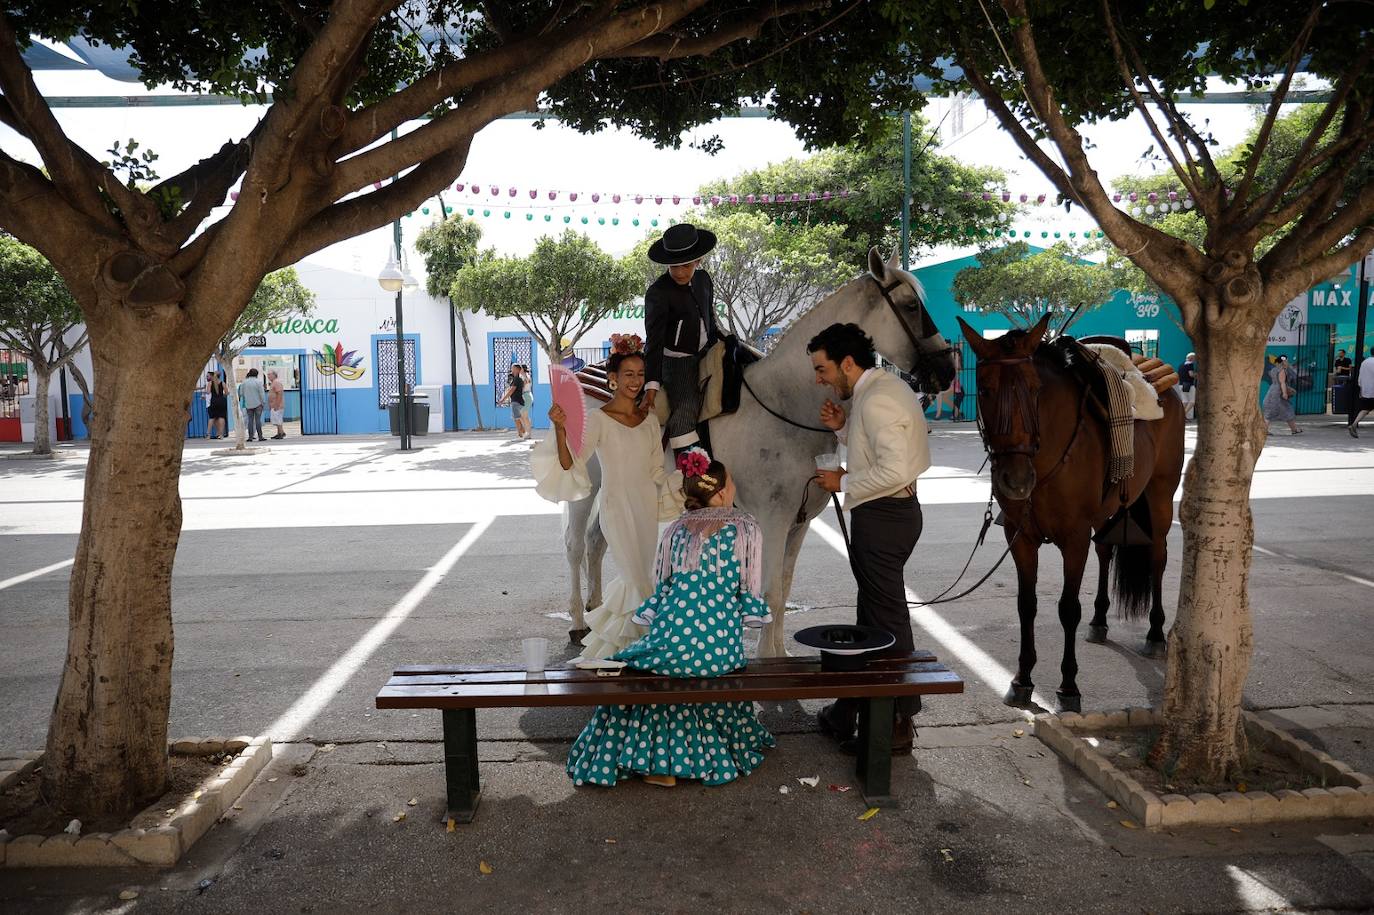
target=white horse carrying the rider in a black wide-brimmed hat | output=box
[563,249,955,658]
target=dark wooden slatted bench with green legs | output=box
[376,651,963,823]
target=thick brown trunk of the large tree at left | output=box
[43,347,194,816]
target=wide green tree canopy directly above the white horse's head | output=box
[699,114,1018,256]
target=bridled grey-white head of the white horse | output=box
[860,247,955,394]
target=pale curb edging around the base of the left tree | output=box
[0,735,272,868]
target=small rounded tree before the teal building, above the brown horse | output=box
[954,242,1117,327]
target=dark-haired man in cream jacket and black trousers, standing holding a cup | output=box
[807,324,930,754]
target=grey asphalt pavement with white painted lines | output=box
[0,423,1374,912]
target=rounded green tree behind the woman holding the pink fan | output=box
[449,229,643,363]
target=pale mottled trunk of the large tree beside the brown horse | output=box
[1151,315,1268,783]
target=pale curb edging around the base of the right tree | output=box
[1035,709,1374,830]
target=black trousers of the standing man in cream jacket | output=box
[830,496,922,727]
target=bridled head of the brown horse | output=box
[958,315,1050,501]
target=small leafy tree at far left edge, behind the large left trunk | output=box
[0,234,89,455]
